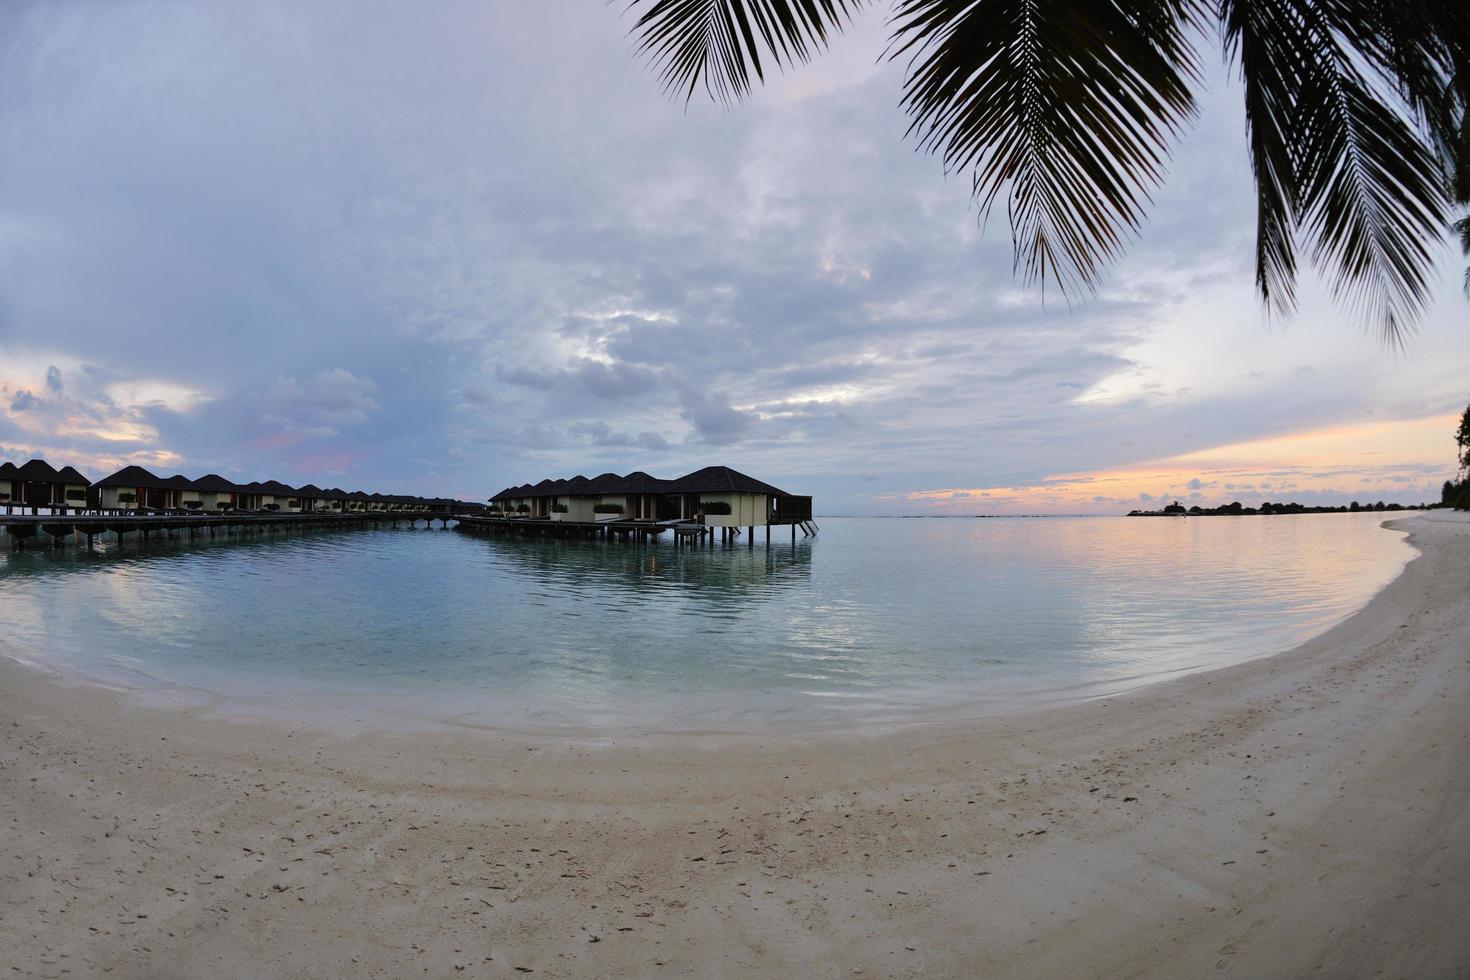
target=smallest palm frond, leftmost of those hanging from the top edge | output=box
[629,0,864,103]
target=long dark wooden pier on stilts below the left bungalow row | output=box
[0,511,446,548]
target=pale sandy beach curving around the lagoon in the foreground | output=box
[0,516,1470,977]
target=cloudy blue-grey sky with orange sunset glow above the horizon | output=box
[0,0,1470,514]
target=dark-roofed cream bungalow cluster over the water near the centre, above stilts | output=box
[490,466,811,527]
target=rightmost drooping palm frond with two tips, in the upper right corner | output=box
[1220,0,1457,344]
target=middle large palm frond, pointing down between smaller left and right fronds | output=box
[891,0,1197,292]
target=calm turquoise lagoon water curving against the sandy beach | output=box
[0,514,1413,732]
